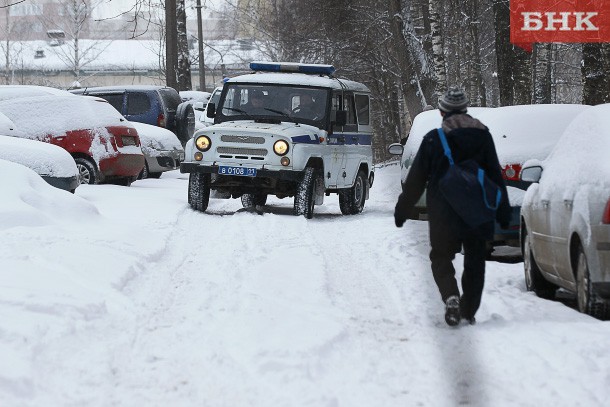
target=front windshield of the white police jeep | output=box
[217,82,330,129]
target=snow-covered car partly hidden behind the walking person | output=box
[389,104,590,247]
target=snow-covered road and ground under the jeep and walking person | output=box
[0,166,610,407]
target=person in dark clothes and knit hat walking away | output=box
[394,87,511,326]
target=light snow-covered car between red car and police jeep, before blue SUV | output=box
[131,122,184,178]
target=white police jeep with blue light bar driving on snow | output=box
[180,62,374,218]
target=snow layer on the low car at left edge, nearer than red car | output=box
[0,135,78,177]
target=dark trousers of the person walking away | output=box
[430,235,487,318]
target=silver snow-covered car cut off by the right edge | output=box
[521,104,610,317]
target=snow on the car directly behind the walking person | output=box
[405,104,590,164]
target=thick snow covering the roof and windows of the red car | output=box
[0,95,132,139]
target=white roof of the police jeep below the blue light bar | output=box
[228,73,370,93]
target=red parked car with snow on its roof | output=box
[0,95,144,186]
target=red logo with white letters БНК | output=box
[510,0,610,49]
